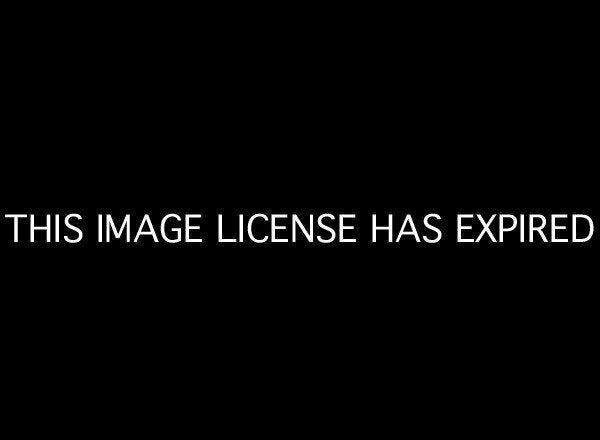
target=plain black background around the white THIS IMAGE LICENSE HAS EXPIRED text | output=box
[1,5,598,433]
